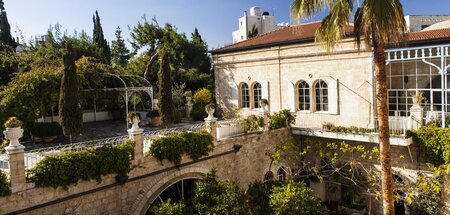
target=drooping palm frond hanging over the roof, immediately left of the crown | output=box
[316,0,354,51]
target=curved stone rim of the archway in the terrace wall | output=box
[128,167,211,215]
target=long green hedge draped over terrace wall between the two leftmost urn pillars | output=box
[27,140,134,189]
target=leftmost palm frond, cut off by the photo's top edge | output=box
[291,0,333,20]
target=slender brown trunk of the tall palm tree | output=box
[373,39,395,215]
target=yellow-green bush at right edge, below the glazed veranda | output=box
[413,126,450,166]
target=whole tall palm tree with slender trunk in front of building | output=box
[291,0,405,215]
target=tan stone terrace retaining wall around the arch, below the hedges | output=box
[0,129,290,215]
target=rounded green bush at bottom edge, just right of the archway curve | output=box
[192,170,249,214]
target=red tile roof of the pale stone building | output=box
[211,22,450,54]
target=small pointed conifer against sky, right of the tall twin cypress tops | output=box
[111,27,130,67]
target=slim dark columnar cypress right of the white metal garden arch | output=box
[158,50,174,126]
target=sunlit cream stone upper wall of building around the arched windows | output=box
[213,40,374,127]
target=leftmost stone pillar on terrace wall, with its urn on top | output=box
[3,127,27,193]
